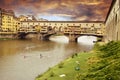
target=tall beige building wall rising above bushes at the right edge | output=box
[105,0,120,42]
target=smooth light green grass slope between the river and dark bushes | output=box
[36,53,94,80]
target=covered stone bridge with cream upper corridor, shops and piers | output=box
[20,21,105,41]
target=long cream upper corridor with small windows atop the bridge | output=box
[21,21,105,34]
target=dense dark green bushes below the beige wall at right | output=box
[76,41,120,80]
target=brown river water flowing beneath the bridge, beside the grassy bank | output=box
[0,36,96,80]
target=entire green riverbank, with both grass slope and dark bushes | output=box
[36,41,120,80]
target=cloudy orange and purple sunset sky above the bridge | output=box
[0,0,112,21]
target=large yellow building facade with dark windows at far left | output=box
[1,9,20,32]
